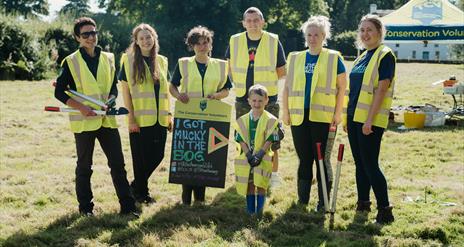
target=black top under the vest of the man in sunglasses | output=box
[55,47,118,104]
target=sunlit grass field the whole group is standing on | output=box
[0,64,464,246]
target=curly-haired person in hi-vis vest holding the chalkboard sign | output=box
[169,26,232,205]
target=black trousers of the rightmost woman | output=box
[347,116,390,208]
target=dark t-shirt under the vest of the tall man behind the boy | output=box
[226,33,286,103]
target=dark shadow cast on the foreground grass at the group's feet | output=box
[4,187,388,246]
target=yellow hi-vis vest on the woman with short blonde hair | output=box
[287,48,343,126]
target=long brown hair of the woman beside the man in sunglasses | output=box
[127,23,159,84]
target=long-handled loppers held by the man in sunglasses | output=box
[44,82,129,115]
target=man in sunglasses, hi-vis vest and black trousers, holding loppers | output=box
[55,17,138,216]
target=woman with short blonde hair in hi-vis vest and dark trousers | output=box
[283,16,347,212]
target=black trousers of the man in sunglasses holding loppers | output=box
[74,127,135,212]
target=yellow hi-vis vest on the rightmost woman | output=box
[353,45,396,128]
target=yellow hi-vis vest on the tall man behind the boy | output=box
[229,31,279,97]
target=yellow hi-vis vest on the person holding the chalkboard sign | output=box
[178,56,228,98]
